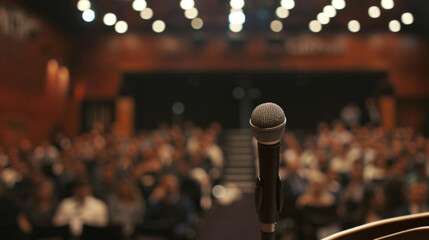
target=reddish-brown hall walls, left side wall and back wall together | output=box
[0,1,429,144]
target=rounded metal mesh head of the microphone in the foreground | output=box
[250,103,286,144]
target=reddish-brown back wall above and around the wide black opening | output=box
[73,33,429,129]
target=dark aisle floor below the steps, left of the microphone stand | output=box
[196,194,260,240]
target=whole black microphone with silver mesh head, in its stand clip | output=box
[249,102,286,240]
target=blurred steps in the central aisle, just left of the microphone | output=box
[223,129,256,193]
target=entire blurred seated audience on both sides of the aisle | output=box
[0,102,429,239]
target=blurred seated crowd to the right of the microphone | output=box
[281,101,429,239]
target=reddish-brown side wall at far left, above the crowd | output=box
[0,1,71,144]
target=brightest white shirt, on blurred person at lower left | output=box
[53,196,109,236]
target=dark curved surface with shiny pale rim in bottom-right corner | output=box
[323,213,429,240]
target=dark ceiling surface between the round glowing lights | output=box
[17,0,429,35]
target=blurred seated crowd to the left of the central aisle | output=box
[0,122,224,239]
